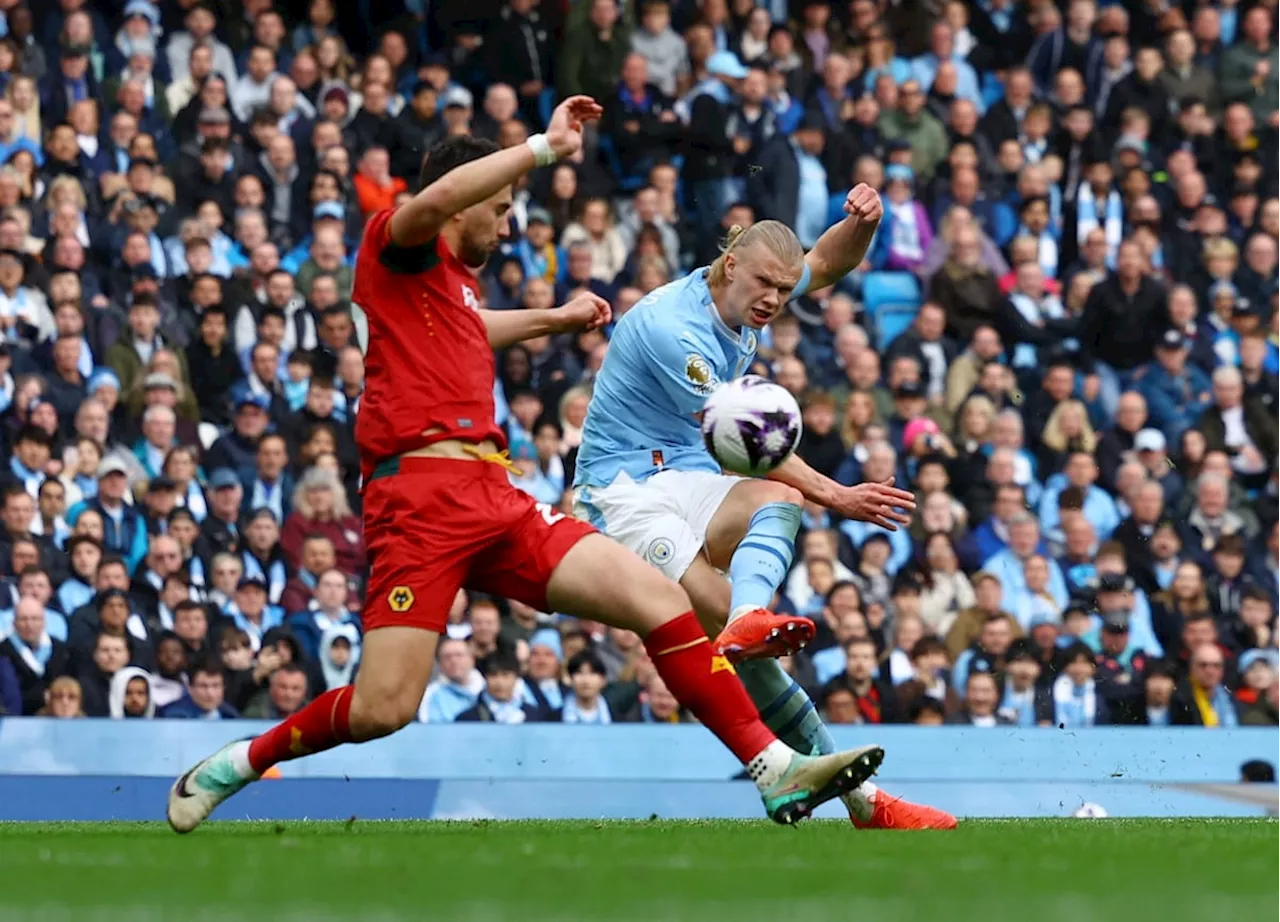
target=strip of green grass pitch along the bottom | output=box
[0,820,1280,922]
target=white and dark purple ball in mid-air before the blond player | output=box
[703,375,800,476]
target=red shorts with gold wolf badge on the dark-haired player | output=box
[362,457,595,633]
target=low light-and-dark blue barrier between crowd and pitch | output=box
[0,718,1280,821]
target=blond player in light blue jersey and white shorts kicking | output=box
[573,184,955,829]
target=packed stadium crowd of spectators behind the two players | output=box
[0,0,1280,727]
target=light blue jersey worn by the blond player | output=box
[573,264,809,487]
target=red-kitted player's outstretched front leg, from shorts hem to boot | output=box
[535,534,883,823]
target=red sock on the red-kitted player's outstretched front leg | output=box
[644,612,776,764]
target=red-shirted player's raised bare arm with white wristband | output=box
[390,96,603,247]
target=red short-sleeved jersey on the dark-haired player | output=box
[352,209,506,480]
